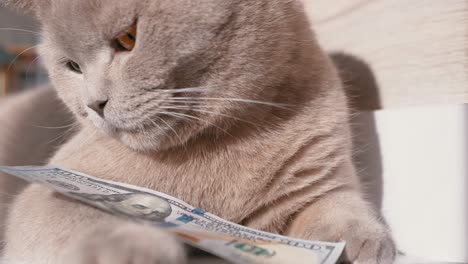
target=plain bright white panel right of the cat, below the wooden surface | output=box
[354,105,468,262]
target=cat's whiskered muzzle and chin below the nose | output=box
[85,91,211,152]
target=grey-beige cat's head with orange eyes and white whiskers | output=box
[6,0,307,151]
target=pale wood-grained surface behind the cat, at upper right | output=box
[302,0,468,109]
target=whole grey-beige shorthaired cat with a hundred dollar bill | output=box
[1,0,395,264]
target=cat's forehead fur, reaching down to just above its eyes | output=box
[42,0,235,56]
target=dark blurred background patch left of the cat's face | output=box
[0,6,47,97]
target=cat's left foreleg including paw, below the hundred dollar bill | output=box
[4,185,186,264]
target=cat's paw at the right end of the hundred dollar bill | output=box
[287,189,396,264]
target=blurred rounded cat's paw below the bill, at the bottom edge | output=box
[60,223,187,264]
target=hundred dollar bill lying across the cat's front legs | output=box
[0,166,345,264]
